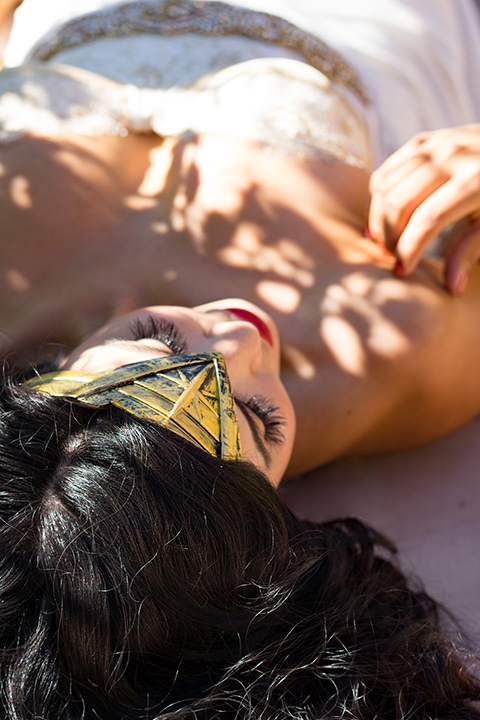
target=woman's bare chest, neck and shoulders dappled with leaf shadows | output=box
[0,131,480,474]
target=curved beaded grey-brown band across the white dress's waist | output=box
[28,0,369,104]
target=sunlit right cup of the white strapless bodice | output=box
[148,58,372,168]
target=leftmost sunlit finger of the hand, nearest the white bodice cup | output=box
[369,158,448,251]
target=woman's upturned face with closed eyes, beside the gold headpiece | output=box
[63,299,295,485]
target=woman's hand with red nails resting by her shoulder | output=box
[369,124,480,295]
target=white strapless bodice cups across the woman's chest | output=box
[0,58,372,168]
